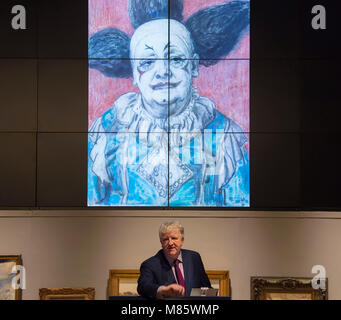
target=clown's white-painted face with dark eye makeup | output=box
[132,24,198,118]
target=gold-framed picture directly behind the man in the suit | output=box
[109,269,230,296]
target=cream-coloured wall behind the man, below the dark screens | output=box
[0,210,341,299]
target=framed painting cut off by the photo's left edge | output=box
[0,255,22,300]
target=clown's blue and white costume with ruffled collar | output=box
[88,89,250,207]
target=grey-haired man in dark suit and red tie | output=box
[137,221,211,299]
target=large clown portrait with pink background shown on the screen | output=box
[88,0,250,207]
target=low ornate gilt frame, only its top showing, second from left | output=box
[39,287,95,300]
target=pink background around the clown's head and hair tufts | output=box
[89,0,250,142]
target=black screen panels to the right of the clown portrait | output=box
[250,0,341,210]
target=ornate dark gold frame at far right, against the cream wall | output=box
[251,277,328,300]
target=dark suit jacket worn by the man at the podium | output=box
[137,249,211,299]
